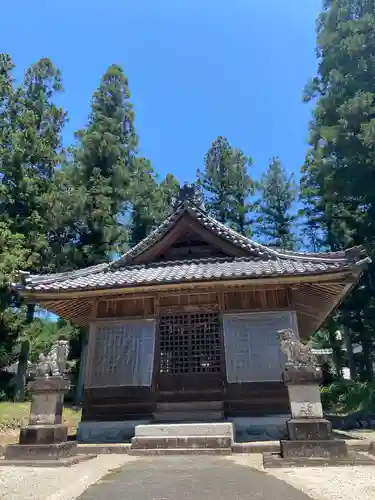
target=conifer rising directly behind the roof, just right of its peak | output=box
[197,136,253,233]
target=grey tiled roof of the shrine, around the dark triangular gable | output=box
[16,201,369,292]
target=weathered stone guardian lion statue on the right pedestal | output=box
[277,328,318,368]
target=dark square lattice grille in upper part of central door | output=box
[159,313,221,374]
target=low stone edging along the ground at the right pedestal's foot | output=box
[263,452,375,469]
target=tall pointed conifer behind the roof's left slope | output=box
[73,65,137,267]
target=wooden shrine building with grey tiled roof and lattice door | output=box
[16,186,369,442]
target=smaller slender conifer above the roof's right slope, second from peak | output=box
[256,158,297,250]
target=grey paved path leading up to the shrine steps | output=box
[79,456,309,500]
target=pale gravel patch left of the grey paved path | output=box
[0,455,135,500]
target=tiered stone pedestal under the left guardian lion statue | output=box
[2,377,95,466]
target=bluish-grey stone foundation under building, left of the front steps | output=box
[77,420,149,443]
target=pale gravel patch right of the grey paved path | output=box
[230,455,375,500]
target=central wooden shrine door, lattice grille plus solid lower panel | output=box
[156,312,225,399]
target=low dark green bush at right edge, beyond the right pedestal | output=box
[321,380,375,413]
